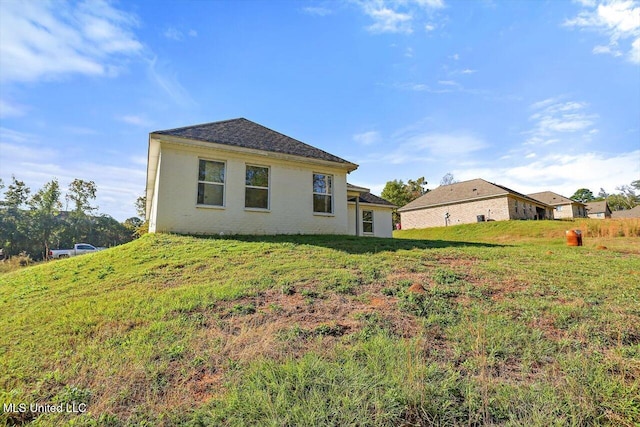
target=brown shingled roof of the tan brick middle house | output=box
[398,179,546,212]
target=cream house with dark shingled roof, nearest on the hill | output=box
[146,118,393,237]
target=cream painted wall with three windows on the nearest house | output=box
[150,142,348,234]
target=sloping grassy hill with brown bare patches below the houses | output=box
[0,222,640,426]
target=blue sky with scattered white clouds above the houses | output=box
[0,0,640,220]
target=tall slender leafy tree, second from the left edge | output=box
[29,179,62,258]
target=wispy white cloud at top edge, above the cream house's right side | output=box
[355,0,445,34]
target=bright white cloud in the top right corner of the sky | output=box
[563,0,640,64]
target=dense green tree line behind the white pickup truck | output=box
[0,176,143,260]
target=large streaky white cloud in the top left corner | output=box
[0,0,142,83]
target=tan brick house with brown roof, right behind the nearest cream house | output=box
[398,179,553,230]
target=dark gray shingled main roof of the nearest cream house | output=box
[151,118,358,169]
